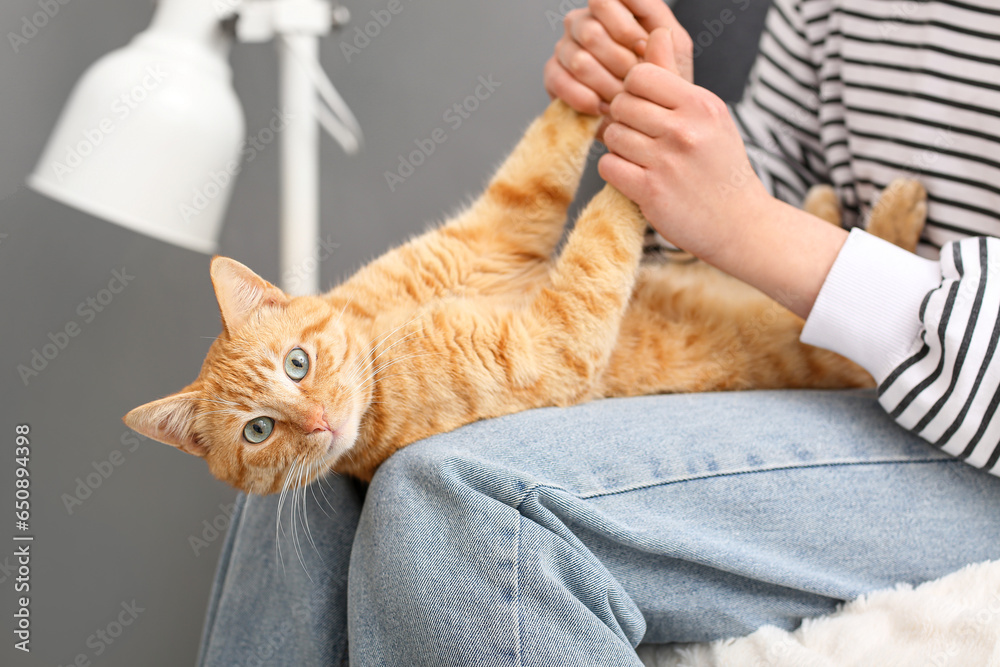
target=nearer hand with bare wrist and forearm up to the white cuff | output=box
[598,29,847,317]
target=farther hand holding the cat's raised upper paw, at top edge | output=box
[545,0,694,116]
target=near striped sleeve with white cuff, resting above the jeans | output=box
[802,230,1000,475]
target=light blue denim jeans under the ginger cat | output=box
[193,391,1000,667]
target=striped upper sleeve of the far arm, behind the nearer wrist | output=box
[730,0,827,205]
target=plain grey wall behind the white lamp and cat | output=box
[0,0,766,667]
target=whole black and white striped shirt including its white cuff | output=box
[732,0,1000,475]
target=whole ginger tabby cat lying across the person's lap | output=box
[125,101,923,494]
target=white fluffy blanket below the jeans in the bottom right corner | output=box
[638,561,1000,667]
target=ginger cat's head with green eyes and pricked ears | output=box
[125,258,371,494]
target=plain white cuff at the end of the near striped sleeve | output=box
[801,229,941,383]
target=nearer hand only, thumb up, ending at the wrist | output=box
[599,29,771,262]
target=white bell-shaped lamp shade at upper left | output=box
[28,0,245,253]
